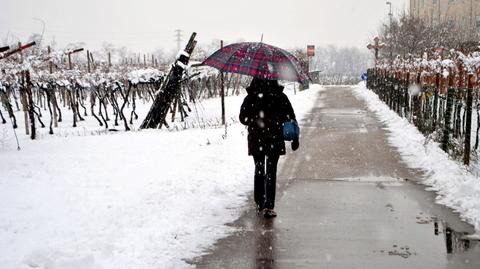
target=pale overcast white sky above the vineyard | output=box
[0,0,406,52]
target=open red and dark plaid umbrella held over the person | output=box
[203,42,310,83]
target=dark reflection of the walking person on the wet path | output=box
[255,217,275,269]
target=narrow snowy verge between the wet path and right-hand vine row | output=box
[354,83,480,232]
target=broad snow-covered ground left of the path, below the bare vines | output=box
[0,82,321,269]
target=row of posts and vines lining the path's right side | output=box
[367,66,480,165]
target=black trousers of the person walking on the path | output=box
[253,154,280,209]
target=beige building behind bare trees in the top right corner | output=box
[410,0,480,32]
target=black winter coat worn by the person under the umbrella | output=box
[240,81,295,156]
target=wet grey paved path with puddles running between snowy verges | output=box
[191,88,480,269]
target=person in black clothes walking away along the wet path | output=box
[240,78,299,218]
